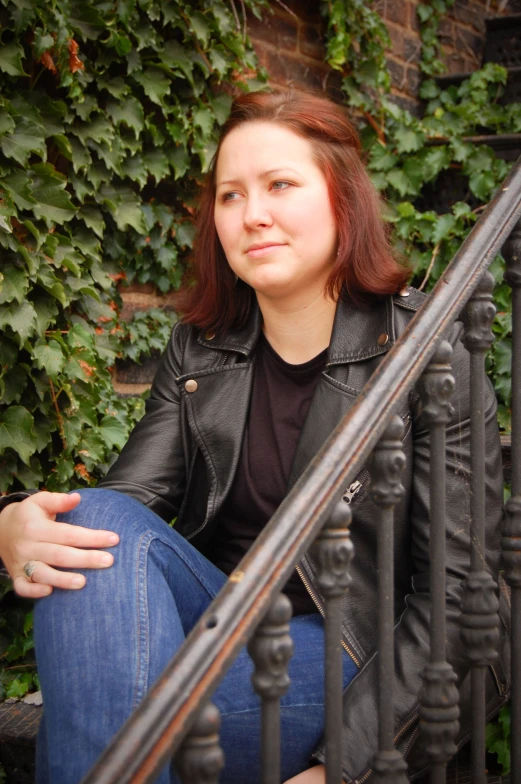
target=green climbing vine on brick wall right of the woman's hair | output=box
[322,0,521,431]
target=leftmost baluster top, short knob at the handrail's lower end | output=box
[174,702,224,784]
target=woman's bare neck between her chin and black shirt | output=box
[258,294,336,365]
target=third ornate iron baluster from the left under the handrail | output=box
[311,501,353,784]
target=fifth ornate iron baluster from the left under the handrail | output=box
[420,341,459,784]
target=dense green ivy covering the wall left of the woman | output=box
[0,0,265,698]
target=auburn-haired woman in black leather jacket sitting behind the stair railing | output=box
[0,92,506,784]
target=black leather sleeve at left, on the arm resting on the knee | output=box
[98,324,189,522]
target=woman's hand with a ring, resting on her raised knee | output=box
[0,492,119,599]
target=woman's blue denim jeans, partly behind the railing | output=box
[35,489,357,784]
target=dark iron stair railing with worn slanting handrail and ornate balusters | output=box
[80,159,521,784]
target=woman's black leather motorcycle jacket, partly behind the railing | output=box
[100,289,508,782]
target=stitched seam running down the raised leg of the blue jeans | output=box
[132,531,155,708]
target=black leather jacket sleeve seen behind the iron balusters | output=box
[315,330,503,782]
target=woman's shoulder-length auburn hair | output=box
[175,89,410,332]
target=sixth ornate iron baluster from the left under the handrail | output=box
[461,272,499,784]
